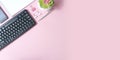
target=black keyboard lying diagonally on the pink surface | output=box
[0,10,36,50]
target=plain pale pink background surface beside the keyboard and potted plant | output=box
[0,0,120,60]
